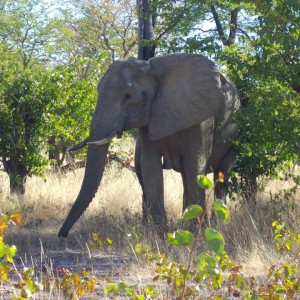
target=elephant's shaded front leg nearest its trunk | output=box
[141,143,166,224]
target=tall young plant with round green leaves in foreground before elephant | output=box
[106,173,235,299]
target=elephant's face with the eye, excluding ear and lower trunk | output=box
[89,59,158,145]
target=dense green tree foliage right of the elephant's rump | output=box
[218,0,300,196]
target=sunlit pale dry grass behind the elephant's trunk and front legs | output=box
[0,158,182,238]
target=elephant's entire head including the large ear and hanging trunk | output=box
[59,55,237,237]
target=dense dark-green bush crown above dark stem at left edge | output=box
[0,69,55,175]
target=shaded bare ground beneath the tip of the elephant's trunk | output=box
[0,228,145,299]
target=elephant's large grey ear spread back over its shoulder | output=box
[148,54,228,140]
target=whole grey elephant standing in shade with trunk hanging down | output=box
[59,54,239,237]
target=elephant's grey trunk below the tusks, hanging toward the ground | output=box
[58,143,109,237]
